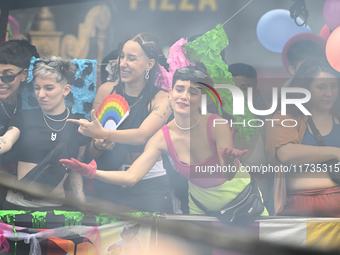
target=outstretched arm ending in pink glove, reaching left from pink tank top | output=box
[60,132,165,186]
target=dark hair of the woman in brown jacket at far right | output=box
[287,59,340,117]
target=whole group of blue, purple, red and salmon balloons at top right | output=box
[256,0,340,72]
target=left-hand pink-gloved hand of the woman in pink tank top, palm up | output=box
[59,158,97,179]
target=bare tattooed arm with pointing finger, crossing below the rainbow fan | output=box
[68,91,171,145]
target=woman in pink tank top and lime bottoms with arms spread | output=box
[61,63,260,214]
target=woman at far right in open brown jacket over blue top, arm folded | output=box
[266,61,340,217]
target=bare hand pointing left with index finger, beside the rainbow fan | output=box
[67,109,109,139]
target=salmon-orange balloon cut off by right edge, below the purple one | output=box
[326,27,340,72]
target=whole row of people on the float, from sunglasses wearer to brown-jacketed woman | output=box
[0,33,340,219]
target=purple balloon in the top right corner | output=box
[323,0,340,30]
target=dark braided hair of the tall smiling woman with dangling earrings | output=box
[116,32,160,111]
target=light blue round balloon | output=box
[256,9,312,52]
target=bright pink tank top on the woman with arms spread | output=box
[162,114,229,188]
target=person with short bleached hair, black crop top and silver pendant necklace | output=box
[0,56,91,210]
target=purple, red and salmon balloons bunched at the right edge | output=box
[320,0,340,72]
